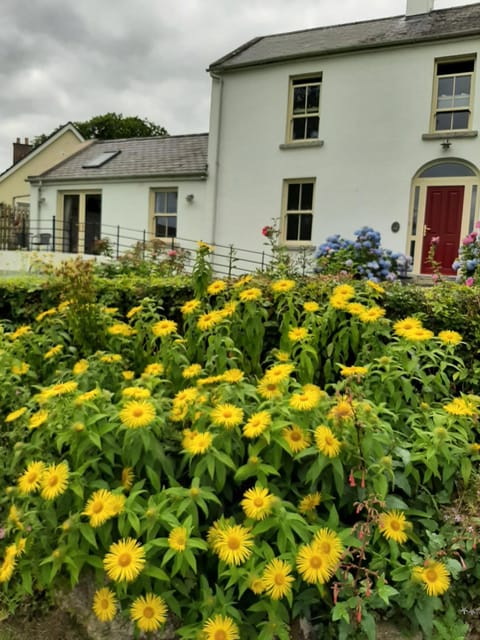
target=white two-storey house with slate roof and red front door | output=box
[203,0,480,274]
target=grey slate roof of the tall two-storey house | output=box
[208,3,480,72]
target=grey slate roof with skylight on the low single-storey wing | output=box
[29,133,208,182]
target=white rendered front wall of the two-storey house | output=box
[209,39,480,252]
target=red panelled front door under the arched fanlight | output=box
[421,187,464,275]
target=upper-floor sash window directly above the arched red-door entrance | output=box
[432,57,475,131]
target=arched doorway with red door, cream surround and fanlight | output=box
[408,158,480,275]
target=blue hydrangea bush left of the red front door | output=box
[314,226,411,282]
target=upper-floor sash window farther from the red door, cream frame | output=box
[288,75,322,142]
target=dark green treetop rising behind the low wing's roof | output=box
[33,113,168,148]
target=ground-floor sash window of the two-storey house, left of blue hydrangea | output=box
[283,180,314,243]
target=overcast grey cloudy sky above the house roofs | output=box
[0,0,475,172]
